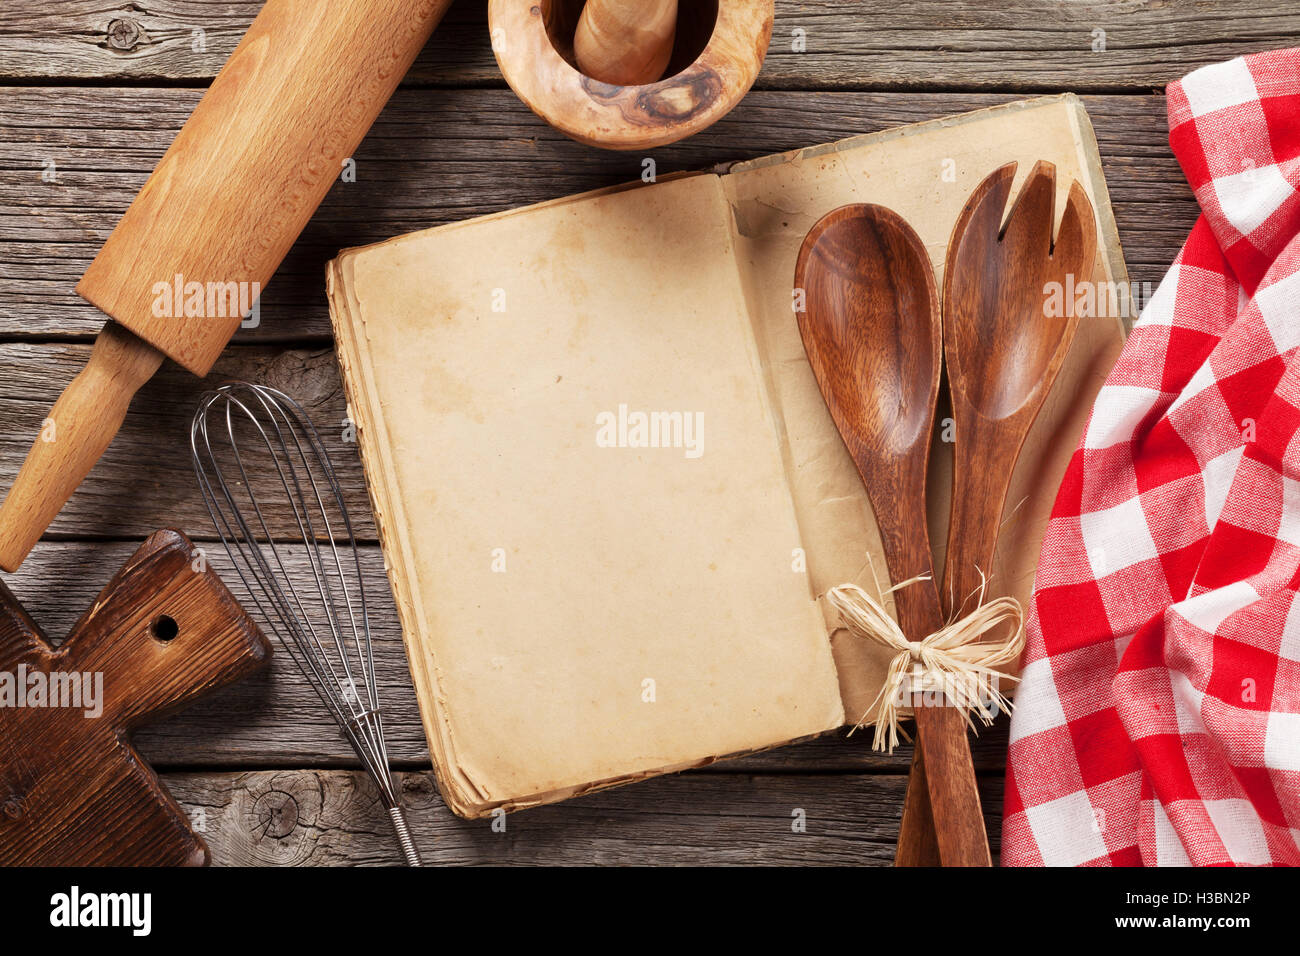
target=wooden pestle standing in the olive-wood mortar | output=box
[573,0,677,86]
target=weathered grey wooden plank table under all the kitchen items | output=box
[0,0,1300,865]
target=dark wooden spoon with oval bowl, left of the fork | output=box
[794,206,989,866]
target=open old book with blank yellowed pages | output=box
[329,96,1127,817]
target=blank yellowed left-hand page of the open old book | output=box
[330,176,844,816]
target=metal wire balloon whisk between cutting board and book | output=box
[190,382,420,866]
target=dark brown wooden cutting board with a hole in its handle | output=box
[0,531,270,866]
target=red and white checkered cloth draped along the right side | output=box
[1002,49,1300,865]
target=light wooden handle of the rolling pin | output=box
[0,323,163,571]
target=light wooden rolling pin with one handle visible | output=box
[0,0,451,571]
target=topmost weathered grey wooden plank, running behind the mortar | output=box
[0,0,1300,91]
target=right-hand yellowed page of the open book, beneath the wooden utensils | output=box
[723,95,1127,721]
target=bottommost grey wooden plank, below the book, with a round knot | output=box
[163,770,1002,866]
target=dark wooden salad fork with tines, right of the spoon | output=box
[896,163,1097,866]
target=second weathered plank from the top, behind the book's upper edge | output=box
[0,88,1197,340]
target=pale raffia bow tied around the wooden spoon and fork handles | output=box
[826,576,1024,753]
